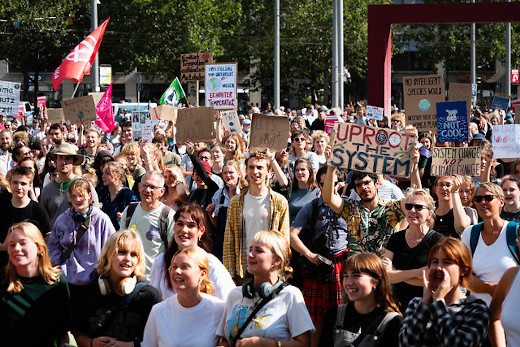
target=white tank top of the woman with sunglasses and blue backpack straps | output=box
[461,222,517,306]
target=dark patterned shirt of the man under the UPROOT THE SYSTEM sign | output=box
[341,199,405,255]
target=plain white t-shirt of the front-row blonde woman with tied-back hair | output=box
[141,293,225,347]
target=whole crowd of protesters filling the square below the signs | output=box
[0,103,520,347]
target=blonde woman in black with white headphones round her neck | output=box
[74,229,161,347]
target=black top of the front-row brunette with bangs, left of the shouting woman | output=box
[319,303,403,347]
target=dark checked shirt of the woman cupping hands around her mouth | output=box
[399,297,490,347]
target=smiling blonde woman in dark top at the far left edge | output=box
[0,222,72,346]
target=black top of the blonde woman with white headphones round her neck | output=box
[75,278,162,342]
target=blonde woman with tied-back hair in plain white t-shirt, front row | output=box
[143,247,225,346]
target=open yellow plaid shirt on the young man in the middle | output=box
[222,189,290,278]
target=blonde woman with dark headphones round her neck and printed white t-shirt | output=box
[217,230,315,346]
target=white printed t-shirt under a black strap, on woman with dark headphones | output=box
[217,285,315,341]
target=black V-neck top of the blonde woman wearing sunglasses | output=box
[386,230,443,312]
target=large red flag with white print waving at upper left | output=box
[52,17,110,90]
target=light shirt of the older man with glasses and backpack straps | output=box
[119,202,175,282]
